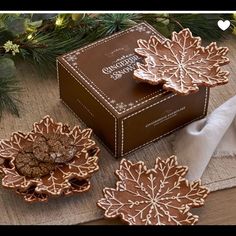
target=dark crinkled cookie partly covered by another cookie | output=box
[15,147,55,178]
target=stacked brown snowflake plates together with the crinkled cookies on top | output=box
[0,116,100,202]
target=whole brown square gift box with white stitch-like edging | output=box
[57,23,209,157]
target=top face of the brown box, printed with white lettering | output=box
[58,23,171,116]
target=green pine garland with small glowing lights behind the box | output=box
[0,14,236,117]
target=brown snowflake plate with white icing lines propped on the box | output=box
[134,29,229,95]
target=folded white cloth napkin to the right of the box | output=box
[173,96,236,180]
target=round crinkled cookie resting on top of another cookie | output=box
[33,133,77,163]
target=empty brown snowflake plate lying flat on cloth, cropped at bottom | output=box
[97,156,209,225]
